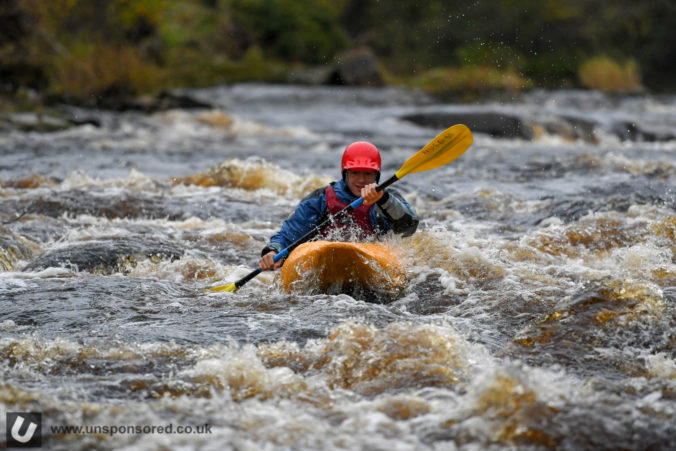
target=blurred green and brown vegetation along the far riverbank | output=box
[0,0,676,104]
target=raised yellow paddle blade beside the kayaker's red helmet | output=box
[395,124,474,179]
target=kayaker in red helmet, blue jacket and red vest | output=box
[258,141,418,271]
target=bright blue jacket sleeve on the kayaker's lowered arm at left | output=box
[261,188,326,255]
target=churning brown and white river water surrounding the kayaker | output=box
[0,85,676,450]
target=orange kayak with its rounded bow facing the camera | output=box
[281,241,406,294]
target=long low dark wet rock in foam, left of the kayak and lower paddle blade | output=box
[23,237,183,274]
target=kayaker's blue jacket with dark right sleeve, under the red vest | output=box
[261,180,419,255]
